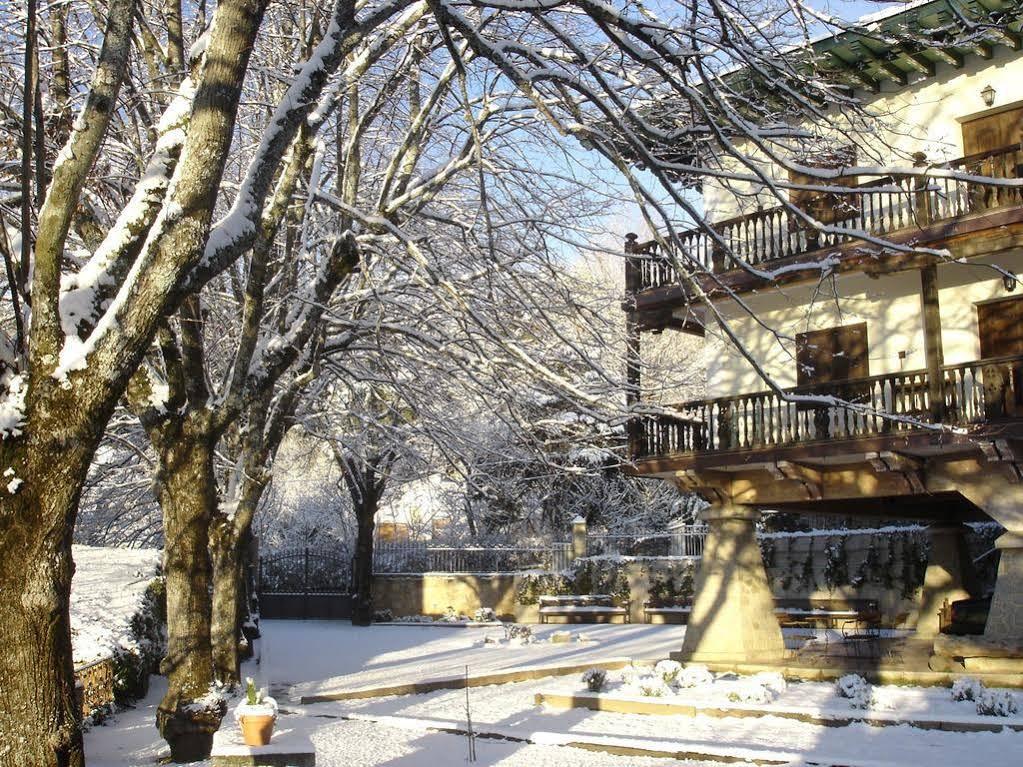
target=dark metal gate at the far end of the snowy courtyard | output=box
[258,547,352,620]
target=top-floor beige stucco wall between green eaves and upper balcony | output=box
[703,46,1023,221]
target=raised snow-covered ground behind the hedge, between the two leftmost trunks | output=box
[71,546,161,666]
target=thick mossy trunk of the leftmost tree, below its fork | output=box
[0,435,95,767]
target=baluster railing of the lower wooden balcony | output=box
[629,357,1023,458]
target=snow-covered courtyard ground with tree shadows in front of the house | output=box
[86,621,1023,767]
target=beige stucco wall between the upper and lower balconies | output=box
[707,251,1023,397]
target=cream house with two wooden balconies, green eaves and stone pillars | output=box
[626,0,1023,660]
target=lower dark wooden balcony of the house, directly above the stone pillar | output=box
[629,357,1023,472]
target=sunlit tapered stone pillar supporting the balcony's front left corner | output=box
[679,504,785,663]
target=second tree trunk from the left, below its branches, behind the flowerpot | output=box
[154,423,224,762]
